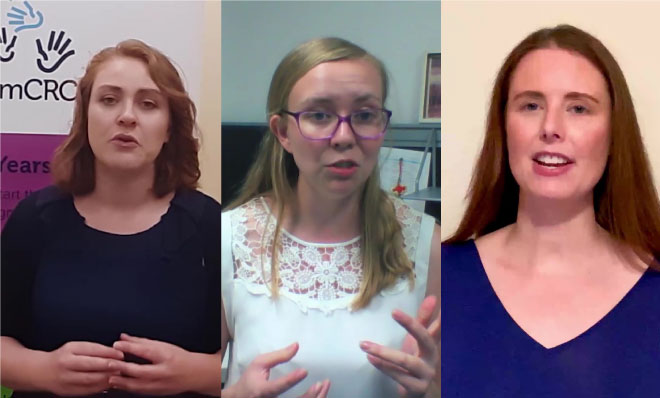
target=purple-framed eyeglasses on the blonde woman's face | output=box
[282,108,392,141]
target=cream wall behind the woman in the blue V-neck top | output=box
[441,0,660,237]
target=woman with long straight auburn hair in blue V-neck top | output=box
[442,25,660,397]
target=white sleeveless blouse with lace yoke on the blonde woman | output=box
[222,198,434,398]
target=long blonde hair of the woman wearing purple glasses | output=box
[228,38,414,310]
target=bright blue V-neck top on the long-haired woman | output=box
[441,241,660,398]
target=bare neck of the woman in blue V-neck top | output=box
[505,192,611,272]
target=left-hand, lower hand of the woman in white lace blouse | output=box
[223,343,330,398]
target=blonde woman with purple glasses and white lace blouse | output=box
[221,38,440,398]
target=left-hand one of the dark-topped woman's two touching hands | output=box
[42,341,124,396]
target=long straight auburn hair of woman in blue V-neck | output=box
[446,25,660,266]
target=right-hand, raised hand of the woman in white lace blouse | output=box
[360,296,440,398]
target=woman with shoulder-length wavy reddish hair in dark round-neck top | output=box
[1,40,221,398]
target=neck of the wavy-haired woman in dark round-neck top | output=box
[85,162,156,209]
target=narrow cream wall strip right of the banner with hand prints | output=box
[197,1,222,202]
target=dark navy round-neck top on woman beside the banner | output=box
[2,187,221,397]
